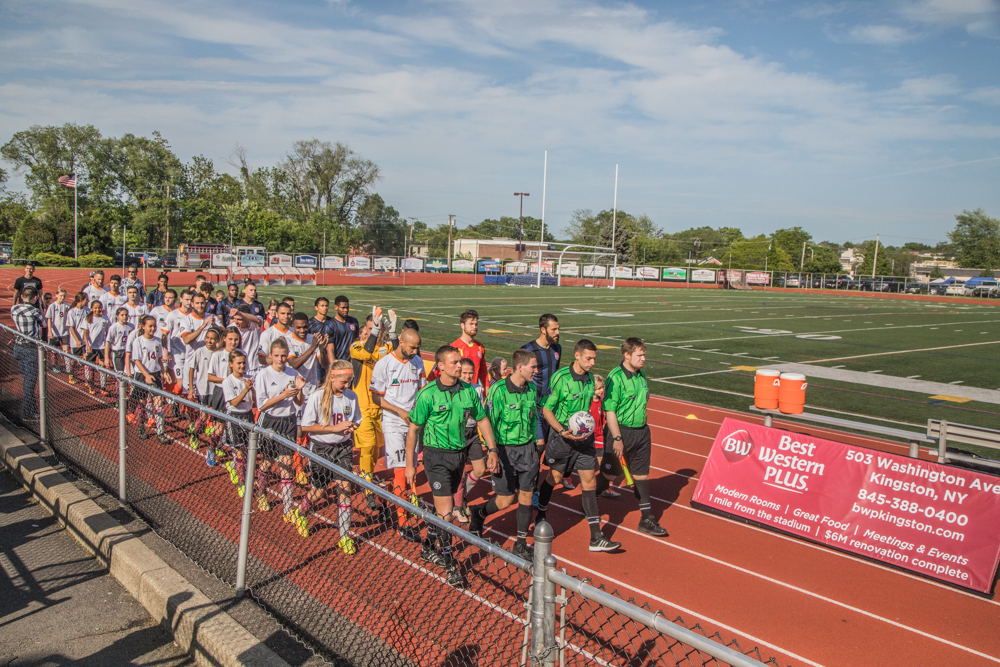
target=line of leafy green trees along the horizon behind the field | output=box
[0,124,1000,275]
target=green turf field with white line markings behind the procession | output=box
[260,285,1000,436]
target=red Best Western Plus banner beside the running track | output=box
[692,418,1000,593]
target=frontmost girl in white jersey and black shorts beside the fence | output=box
[292,362,361,556]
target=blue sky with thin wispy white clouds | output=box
[0,0,1000,243]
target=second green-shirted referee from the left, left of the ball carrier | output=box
[469,349,538,560]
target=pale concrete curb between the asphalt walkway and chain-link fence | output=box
[0,426,288,667]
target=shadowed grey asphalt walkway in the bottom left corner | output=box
[0,469,194,667]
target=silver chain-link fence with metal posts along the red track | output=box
[0,325,796,667]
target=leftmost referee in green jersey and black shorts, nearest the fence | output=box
[406,345,499,588]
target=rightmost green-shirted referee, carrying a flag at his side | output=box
[597,338,667,537]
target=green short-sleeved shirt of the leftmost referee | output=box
[410,379,486,450]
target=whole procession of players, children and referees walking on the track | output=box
[46,277,666,585]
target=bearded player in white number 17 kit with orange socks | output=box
[371,329,427,542]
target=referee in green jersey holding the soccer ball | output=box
[535,339,621,551]
